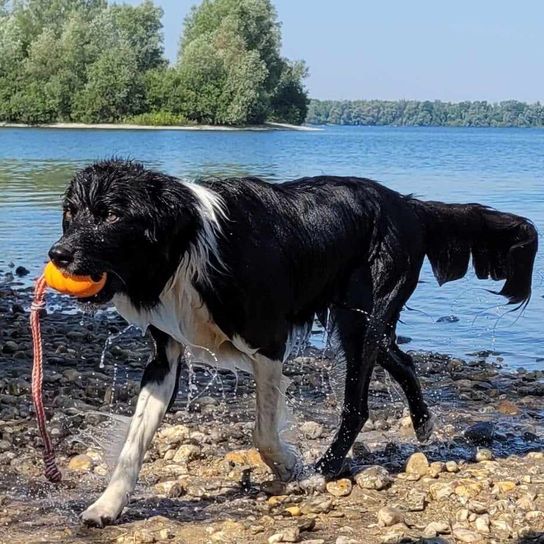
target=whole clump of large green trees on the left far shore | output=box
[0,0,307,125]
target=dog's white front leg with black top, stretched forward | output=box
[81,328,182,527]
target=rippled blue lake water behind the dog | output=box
[0,127,544,368]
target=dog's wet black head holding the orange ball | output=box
[49,160,197,305]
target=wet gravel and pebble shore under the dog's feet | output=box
[0,275,544,544]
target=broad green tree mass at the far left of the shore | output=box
[0,0,166,123]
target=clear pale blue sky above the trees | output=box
[124,0,544,102]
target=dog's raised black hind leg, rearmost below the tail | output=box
[378,342,434,442]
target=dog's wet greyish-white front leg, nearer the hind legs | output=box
[253,355,299,481]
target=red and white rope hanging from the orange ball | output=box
[30,276,62,482]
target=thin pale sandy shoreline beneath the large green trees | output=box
[0,123,323,132]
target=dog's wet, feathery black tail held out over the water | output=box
[411,199,538,304]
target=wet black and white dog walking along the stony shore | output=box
[49,160,537,526]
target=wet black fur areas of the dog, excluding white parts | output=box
[47,160,537,474]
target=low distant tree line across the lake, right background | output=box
[306,100,544,127]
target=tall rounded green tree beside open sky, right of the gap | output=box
[178,0,306,125]
